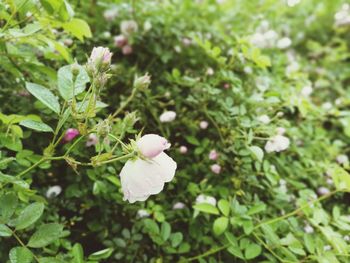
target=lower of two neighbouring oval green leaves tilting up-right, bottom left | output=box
[28,223,63,248]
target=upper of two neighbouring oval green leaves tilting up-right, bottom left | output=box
[13,202,44,230]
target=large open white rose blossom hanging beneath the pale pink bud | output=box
[120,141,177,203]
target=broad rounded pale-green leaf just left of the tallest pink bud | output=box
[57,64,90,101]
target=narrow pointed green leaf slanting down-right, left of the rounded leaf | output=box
[26,82,60,114]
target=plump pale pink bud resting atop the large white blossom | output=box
[136,134,171,158]
